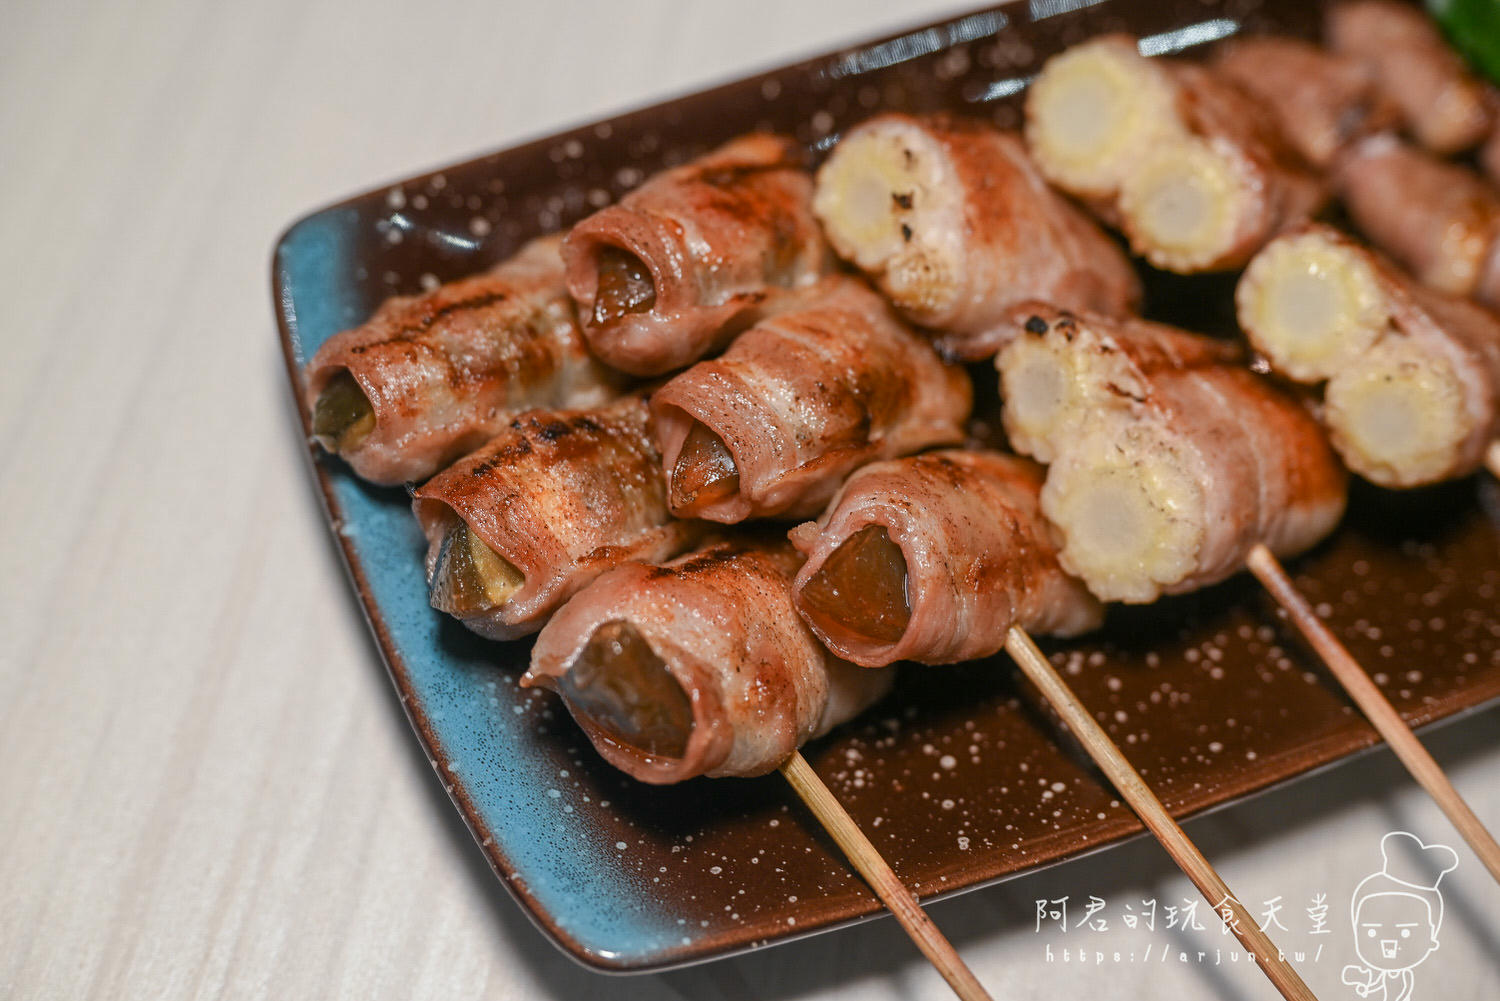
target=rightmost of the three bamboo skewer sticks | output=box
[1247,543,1500,881]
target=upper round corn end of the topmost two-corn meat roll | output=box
[1026,39,1182,198]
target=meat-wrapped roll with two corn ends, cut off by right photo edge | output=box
[1235,225,1500,488]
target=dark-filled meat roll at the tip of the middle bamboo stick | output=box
[792,449,1104,666]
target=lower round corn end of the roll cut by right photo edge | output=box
[1326,336,1476,486]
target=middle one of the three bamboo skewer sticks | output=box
[1005,627,1317,1001]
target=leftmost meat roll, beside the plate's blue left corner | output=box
[306,237,621,483]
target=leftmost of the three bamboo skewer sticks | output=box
[782,750,992,1001]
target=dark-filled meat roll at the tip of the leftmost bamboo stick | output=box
[521,539,894,783]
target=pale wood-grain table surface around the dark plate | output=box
[0,0,1500,1001]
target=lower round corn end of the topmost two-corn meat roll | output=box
[1119,138,1251,272]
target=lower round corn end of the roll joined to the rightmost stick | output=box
[1041,422,1203,603]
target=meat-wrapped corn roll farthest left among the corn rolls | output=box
[813,114,1140,359]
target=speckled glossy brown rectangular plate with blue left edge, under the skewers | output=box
[273,0,1500,971]
